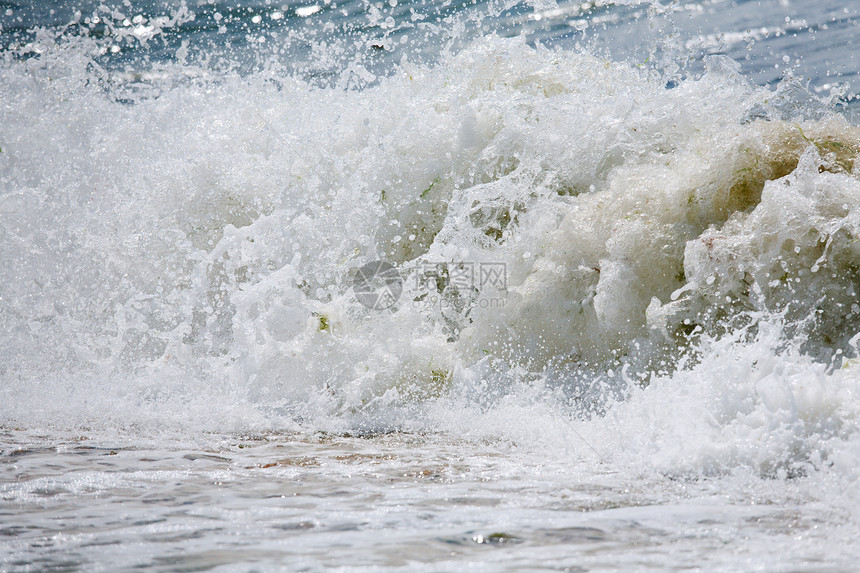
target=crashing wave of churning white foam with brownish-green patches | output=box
[0,20,860,484]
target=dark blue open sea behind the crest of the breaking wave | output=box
[5,0,860,111]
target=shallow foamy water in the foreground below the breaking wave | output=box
[0,430,860,571]
